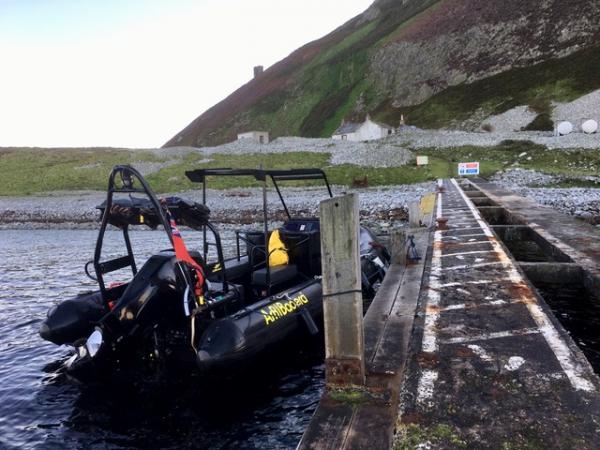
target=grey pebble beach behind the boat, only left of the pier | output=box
[0,183,435,228]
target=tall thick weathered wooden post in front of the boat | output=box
[320,194,365,386]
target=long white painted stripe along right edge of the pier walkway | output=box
[451,179,596,391]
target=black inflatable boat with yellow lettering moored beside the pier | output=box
[40,166,389,377]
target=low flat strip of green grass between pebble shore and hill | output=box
[0,141,600,196]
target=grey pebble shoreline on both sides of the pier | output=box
[0,170,600,229]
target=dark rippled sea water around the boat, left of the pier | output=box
[0,230,324,449]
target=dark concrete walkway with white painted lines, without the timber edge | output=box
[396,180,600,449]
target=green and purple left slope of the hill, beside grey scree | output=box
[165,0,437,147]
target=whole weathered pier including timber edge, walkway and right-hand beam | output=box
[300,180,600,449]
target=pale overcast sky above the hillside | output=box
[0,0,372,147]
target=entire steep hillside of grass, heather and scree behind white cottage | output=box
[166,0,600,146]
